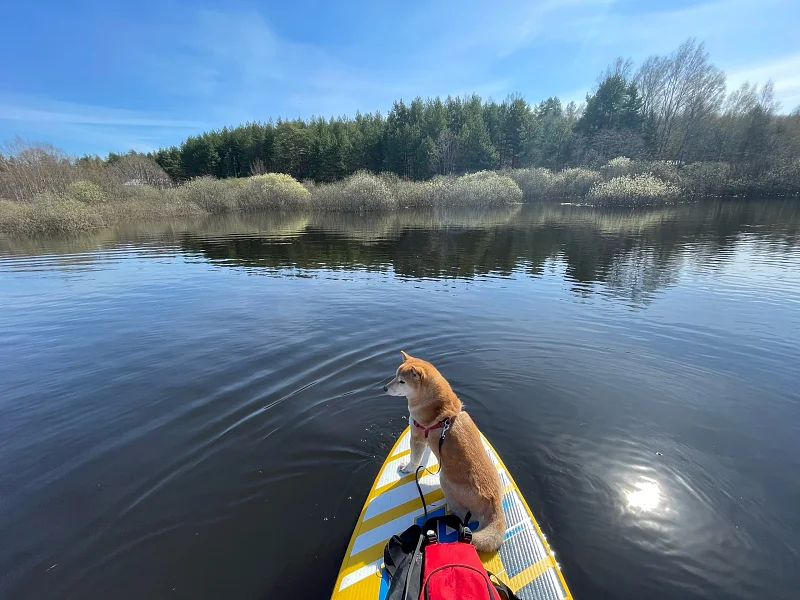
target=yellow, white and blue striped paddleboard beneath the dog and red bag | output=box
[332,428,572,600]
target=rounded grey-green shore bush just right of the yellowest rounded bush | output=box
[311,171,397,212]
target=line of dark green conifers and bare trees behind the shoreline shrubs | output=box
[128,39,800,182]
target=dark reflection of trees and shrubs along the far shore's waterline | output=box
[6,201,800,304]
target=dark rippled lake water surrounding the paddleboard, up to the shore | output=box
[0,201,800,600]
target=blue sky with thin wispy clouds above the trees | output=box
[0,0,800,155]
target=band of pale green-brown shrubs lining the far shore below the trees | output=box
[0,147,800,236]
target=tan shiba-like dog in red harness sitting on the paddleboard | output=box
[383,352,506,552]
